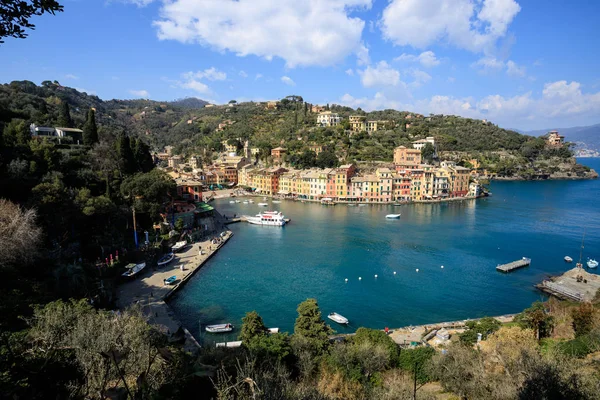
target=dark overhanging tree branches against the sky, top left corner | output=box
[0,0,63,43]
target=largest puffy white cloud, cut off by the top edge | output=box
[152,0,372,68]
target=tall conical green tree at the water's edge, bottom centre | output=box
[294,299,333,353]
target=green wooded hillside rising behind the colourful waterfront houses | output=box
[0,81,586,179]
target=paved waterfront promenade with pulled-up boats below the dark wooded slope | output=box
[117,231,233,351]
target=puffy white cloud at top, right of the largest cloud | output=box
[380,0,521,52]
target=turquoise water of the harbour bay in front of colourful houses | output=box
[170,159,600,340]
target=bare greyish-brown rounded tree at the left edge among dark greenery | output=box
[0,199,42,268]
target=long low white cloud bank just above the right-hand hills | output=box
[340,81,600,129]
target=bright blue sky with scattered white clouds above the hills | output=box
[0,0,600,130]
